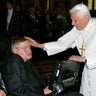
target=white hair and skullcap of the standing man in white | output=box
[69,3,91,18]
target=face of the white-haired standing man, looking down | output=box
[71,13,87,30]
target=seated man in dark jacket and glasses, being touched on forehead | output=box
[2,37,52,96]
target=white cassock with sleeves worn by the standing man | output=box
[45,18,96,96]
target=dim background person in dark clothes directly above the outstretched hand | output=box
[25,6,40,40]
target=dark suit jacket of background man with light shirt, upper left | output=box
[1,10,20,37]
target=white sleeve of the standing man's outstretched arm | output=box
[45,27,78,55]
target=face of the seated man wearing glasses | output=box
[15,41,32,62]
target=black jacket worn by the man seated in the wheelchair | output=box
[2,54,46,96]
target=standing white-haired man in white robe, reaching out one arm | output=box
[25,3,96,96]
